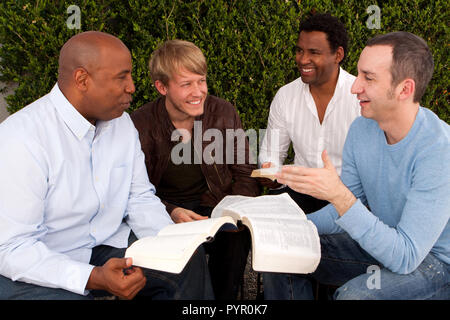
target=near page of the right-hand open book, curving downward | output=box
[243,217,321,273]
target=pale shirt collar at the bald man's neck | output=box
[50,84,95,140]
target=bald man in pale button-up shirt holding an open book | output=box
[0,32,213,299]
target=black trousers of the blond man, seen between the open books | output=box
[171,202,251,300]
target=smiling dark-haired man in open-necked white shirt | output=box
[259,14,360,213]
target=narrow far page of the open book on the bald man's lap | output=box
[158,217,235,236]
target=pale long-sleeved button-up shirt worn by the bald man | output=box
[0,85,172,294]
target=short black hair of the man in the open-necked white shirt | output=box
[298,13,348,64]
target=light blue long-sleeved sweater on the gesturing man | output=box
[308,107,450,274]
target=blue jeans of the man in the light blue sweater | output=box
[263,233,450,300]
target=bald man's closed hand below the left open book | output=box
[86,258,147,299]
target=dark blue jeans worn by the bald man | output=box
[0,233,214,300]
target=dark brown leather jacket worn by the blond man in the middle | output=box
[131,95,260,213]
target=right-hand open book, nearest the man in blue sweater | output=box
[211,193,321,273]
